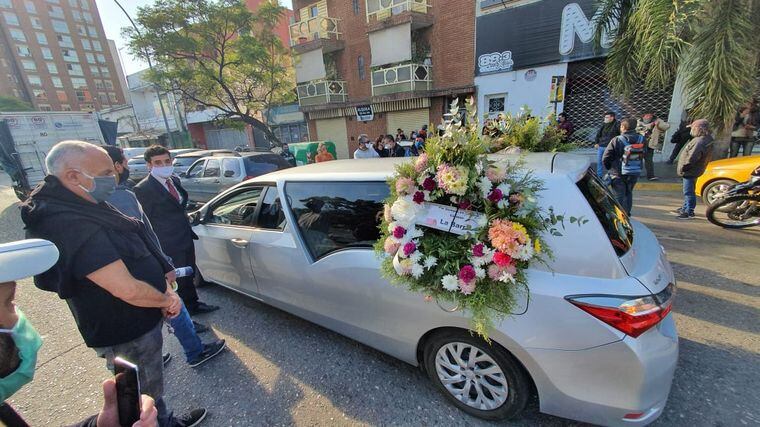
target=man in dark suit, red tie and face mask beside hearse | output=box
[134,145,219,314]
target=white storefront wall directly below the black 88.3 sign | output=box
[475,63,567,119]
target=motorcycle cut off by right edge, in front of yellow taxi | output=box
[707,167,760,228]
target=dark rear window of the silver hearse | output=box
[578,170,633,256]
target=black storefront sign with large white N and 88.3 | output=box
[475,0,612,78]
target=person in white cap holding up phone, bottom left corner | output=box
[0,239,158,427]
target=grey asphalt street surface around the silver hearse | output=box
[0,174,760,426]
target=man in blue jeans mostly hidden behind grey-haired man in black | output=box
[103,145,225,368]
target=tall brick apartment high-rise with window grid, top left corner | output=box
[0,0,126,111]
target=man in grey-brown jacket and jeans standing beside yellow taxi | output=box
[675,119,713,219]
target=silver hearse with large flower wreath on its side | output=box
[190,153,678,426]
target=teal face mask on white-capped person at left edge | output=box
[0,308,42,402]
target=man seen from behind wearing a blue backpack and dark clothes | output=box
[602,119,645,216]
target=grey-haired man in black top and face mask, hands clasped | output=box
[21,141,206,426]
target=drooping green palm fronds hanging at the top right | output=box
[596,0,760,129]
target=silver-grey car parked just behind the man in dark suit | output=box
[179,151,291,203]
